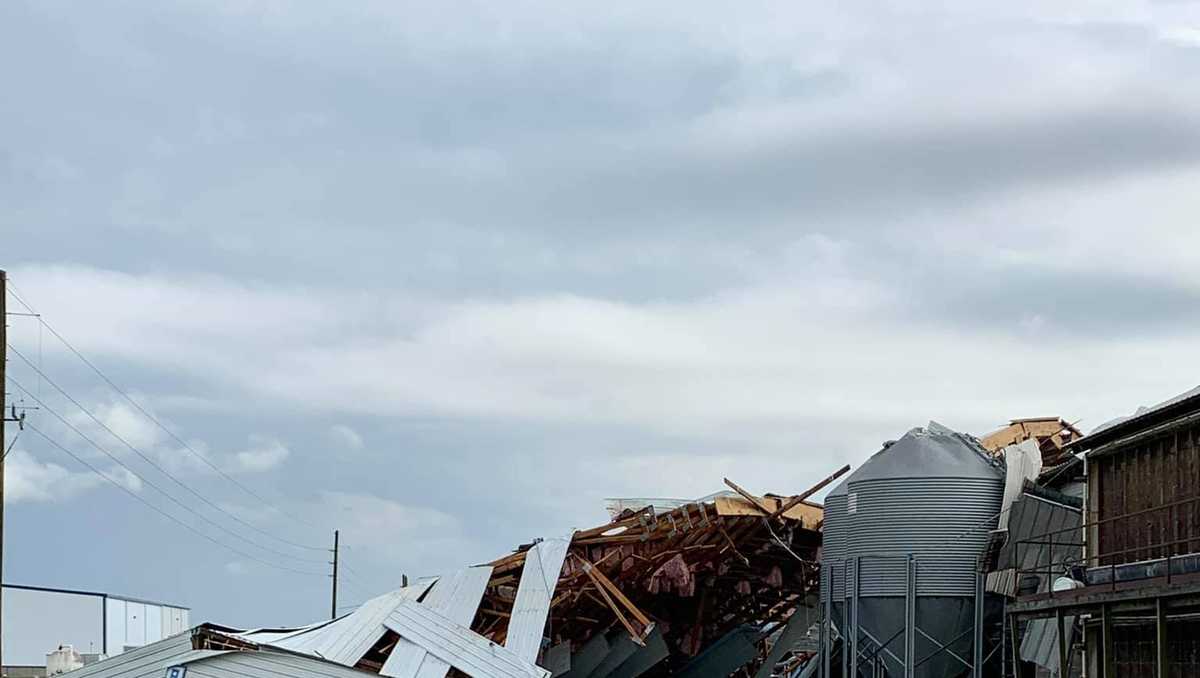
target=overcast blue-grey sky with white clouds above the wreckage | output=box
[0,0,1200,625]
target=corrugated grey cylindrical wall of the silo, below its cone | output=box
[846,476,1003,596]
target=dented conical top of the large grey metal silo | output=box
[834,421,1003,484]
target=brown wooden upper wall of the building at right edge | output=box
[1088,424,1200,565]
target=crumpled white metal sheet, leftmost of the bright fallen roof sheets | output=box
[271,580,434,666]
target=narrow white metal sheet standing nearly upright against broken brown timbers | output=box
[504,536,571,661]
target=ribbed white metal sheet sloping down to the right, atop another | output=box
[384,601,550,678]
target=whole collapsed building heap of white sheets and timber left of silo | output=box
[74,467,848,678]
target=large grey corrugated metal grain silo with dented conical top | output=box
[826,422,1004,678]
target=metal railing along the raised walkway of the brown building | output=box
[1009,496,1200,596]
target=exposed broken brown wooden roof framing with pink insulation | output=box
[472,484,823,678]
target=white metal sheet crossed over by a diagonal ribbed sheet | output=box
[379,566,492,678]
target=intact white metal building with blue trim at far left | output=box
[0,584,190,667]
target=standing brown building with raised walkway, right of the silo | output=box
[1010,389,1200,678]
